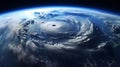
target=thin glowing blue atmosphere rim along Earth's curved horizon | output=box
[0,6,120,16]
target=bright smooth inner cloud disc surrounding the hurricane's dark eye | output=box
[40,21,77,38]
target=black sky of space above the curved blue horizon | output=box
[0,0,120,13]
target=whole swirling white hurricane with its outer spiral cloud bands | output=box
[20,10,93,49]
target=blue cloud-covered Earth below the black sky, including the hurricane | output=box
[0,6,120,67]
